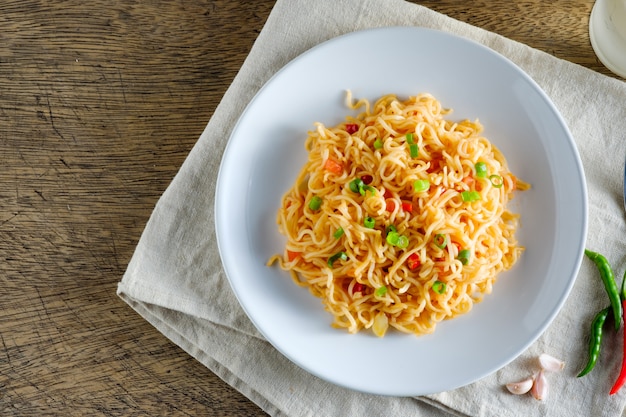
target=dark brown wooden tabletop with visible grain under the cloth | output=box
[0,0,611,416]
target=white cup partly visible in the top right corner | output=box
[589,0,626,78]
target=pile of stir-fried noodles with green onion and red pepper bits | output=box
[268,92,528,336]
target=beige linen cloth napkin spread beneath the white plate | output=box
[118,0,626,417]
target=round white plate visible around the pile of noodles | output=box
[215,27,587,396]
